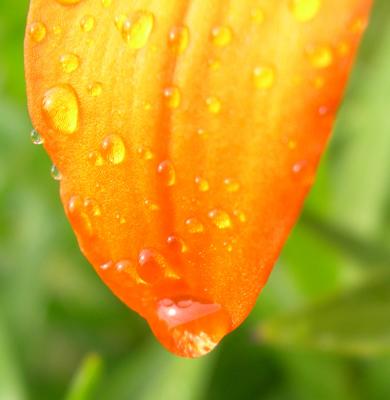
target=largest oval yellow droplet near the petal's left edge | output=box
[42,85,79,134]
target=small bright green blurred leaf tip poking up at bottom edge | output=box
[66,354,103,400]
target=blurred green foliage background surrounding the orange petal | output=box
[0,0,390,400]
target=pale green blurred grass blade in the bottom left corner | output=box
[0,316,26,400]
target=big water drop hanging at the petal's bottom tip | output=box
[152,296,231,358]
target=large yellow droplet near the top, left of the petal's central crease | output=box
[121,11,154,50]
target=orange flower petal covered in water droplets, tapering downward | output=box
[25,0,371,357]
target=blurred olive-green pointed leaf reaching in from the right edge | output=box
[258,273,390,356]
